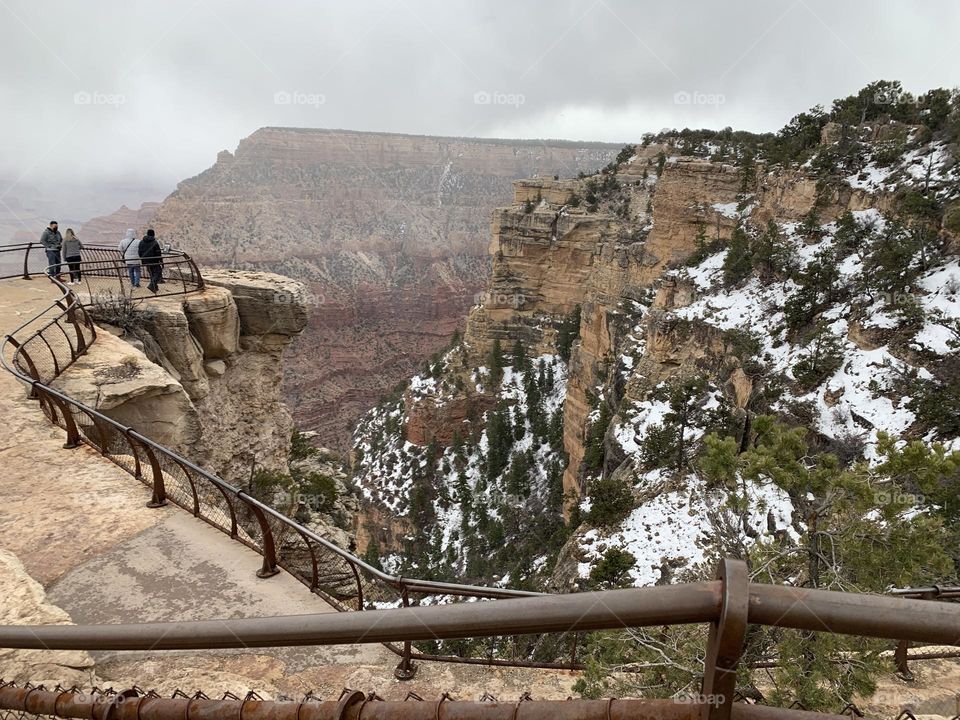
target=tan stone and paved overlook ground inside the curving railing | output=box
[0,279,574,699]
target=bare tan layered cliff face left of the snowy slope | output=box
[464,153,752,493]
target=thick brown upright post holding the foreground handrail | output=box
[701,559,750,720]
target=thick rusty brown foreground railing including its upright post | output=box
[0,560,960,720]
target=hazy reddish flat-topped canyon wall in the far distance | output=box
[83,128,617,447]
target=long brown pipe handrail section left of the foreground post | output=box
[0,581,721,650]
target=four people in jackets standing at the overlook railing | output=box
[40,220,163,293]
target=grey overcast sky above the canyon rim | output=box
[0,0,960,219]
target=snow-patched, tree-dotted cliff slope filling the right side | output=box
[355,90,960,600]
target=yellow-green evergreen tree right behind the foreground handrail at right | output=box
[700,416,960,710]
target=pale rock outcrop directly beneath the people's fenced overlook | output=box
[55,270,307,483]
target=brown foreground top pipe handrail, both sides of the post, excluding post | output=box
[0,580,960,650]
